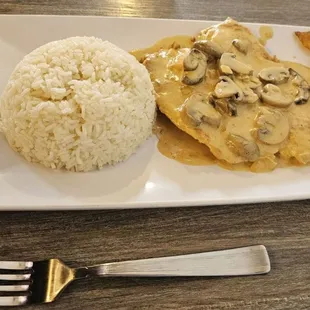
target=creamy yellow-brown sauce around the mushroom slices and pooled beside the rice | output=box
[132,18,310,172]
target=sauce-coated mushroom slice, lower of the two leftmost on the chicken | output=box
[185,93,222,128]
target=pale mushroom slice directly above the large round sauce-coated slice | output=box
[260,84,294,108]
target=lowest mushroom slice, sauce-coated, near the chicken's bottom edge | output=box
[226,134,260,162]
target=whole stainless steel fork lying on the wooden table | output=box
[0,245,270,307]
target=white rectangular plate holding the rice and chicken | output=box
[0,15,310,210]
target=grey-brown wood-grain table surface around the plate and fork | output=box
[0,0,310,310]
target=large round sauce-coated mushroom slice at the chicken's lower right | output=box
[253,108,290,145]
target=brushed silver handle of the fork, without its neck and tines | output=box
[87,245,270,277]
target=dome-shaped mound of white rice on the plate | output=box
[0,37,155,171]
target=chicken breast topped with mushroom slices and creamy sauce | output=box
[134,18,310,171]
